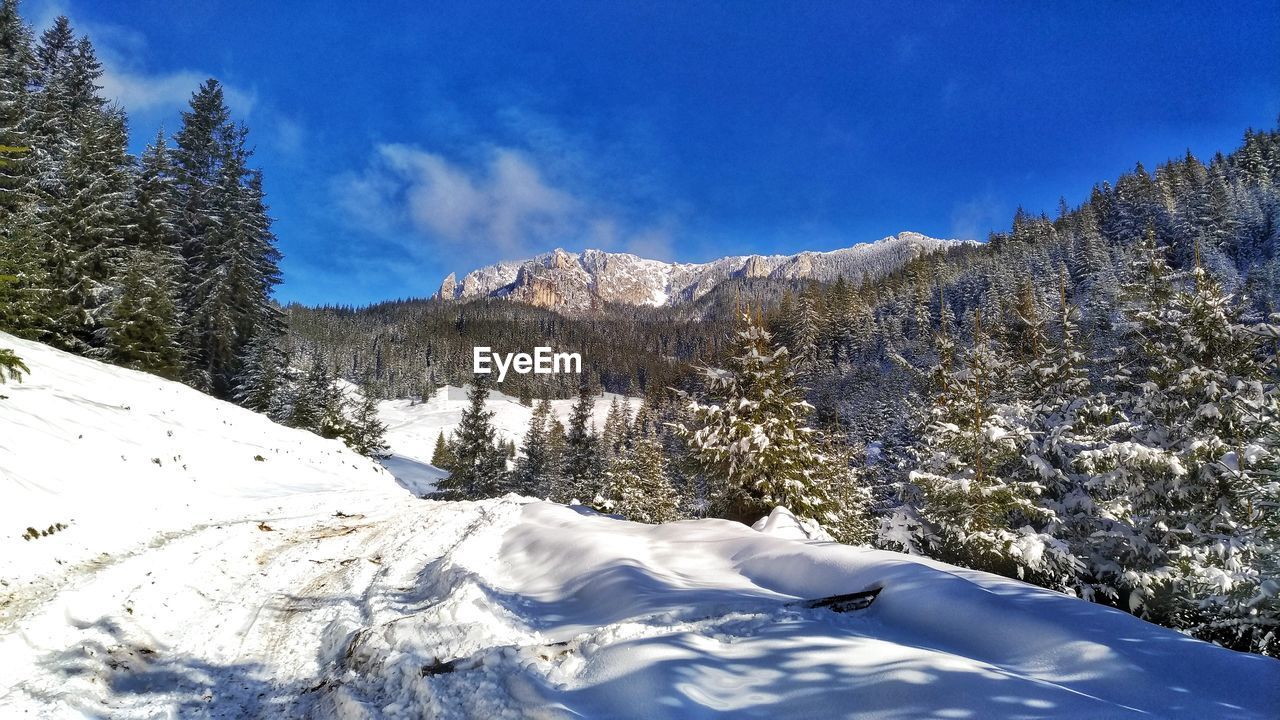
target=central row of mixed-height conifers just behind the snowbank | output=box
[431,316,872,542]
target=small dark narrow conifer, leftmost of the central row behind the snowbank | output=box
[436,375,507,500]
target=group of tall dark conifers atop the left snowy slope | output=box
[0,0,380,454]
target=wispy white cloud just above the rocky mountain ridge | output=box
[334,143,671,263]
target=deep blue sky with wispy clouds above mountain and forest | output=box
[23,0,1280,304]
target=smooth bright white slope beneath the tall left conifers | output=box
[0,333,394,584]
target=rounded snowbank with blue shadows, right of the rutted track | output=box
[329,498,1280,719]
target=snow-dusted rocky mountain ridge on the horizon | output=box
[436,232,973,311]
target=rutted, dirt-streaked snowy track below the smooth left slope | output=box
[0,491,419,717]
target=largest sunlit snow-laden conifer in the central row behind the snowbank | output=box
[680,316,833,523]
